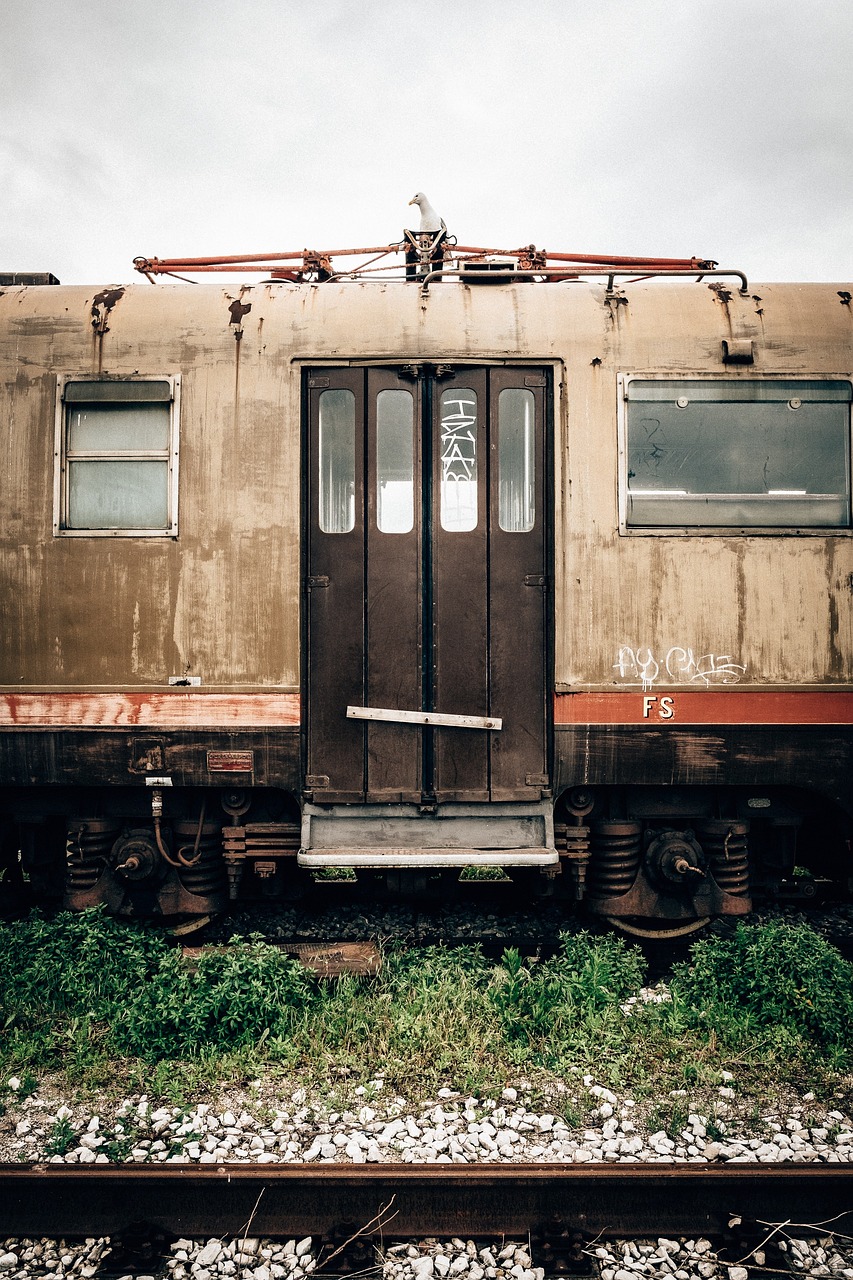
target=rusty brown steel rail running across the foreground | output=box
[0,1164,853,1239]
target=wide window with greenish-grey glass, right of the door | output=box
[625,379,850,530]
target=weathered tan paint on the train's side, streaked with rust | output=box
[0,282,853,711]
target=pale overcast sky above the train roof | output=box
[0,0,853,284]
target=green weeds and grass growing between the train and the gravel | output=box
[0,910,853,1105]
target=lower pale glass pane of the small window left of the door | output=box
[68,461,169,529]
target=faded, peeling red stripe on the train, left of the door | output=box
[0,689,300,728]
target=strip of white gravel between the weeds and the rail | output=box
[0,1070,853,1172]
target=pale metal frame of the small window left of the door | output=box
[54,374,181,539]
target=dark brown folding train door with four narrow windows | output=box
[305,366,548,805]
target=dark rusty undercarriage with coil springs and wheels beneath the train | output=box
[0,786,853,937]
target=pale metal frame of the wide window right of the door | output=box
[616,369,853,538]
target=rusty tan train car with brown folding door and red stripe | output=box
[0,240,853,933]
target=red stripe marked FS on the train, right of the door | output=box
[553,689,853,728]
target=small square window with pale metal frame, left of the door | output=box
[54,376,179,538]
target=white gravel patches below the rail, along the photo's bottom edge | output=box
[0,1234,853,1280]
